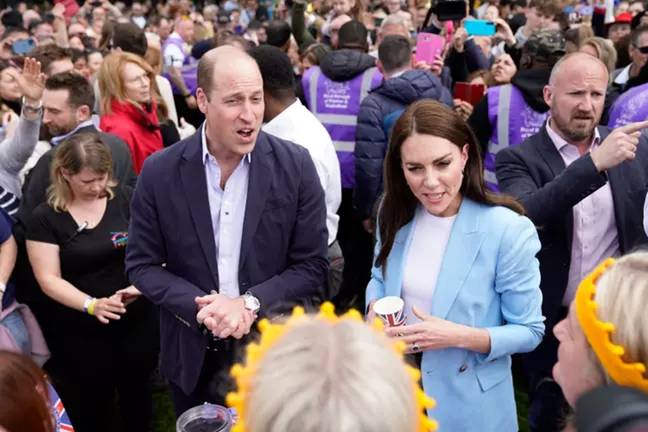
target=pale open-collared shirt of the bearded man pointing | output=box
[547,121,619,306]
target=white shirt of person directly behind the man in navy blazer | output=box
[263,99,342,246]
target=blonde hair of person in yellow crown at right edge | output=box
[595,251,648,376]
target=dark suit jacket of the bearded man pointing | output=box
[496,126,648,368]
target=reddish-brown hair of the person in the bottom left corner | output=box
[0,351,54,432]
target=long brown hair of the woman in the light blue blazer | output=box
[375,99,524,272]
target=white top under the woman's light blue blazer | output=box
[401,206,457,324]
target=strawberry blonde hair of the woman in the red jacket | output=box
[97,52,166,120]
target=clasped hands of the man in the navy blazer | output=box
[195,294,256,339]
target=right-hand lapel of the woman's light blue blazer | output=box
[431,198,486,319]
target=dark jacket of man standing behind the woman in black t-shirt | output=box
[18,126,137,221]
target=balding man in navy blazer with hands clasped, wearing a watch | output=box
[126,47,328,415]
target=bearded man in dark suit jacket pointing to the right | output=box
[496,53,648,432]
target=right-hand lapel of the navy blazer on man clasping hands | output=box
[239,132,273,270]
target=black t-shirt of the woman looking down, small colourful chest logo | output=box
[26,188,159,354]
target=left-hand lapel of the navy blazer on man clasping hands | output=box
[180,126,218,286]
